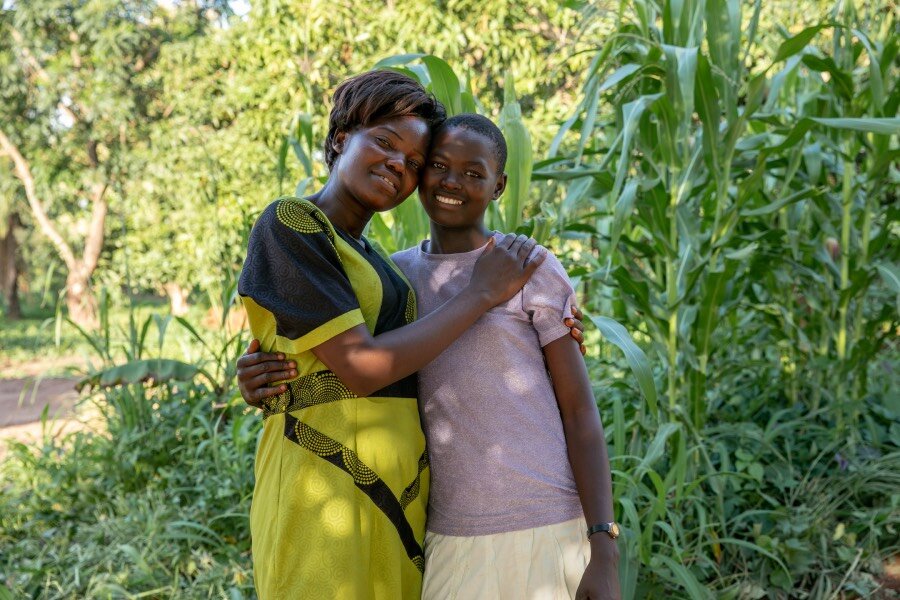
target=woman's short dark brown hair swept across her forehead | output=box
[325,70,447,171]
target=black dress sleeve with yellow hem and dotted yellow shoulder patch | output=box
[238,199,365,354]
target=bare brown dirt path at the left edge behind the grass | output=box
[0,377,78,459]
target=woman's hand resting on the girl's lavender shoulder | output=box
[469,233,547,306]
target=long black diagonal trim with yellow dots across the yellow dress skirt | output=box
[284,414,425,573]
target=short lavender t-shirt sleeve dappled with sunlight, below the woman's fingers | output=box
[522,251,575,348]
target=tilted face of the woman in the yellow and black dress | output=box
[332,117,430,212]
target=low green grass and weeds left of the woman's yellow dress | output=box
[0,300,260,598]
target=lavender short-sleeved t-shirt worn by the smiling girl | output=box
[392,234,582,536]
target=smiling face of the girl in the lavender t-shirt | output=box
[419,127,506,228]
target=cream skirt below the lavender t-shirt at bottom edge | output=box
[422,518,591,600]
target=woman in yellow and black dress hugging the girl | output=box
[238,71,543,600]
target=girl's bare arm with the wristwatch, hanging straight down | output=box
[543,336,620,600]
